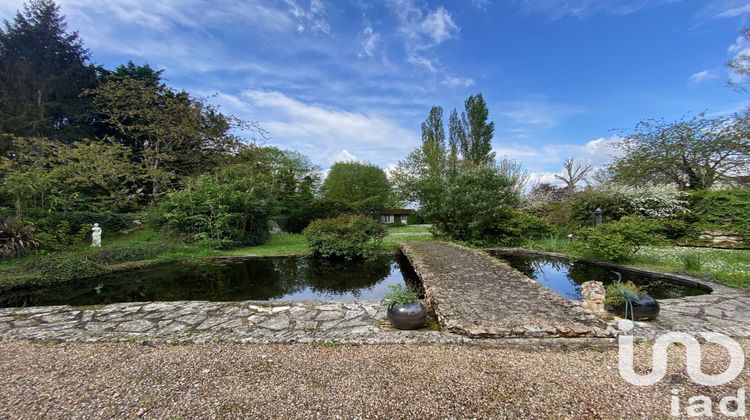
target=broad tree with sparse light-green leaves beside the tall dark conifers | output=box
[87,63,242,201]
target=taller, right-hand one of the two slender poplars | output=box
[457,93,495,165]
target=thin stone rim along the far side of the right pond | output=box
[483,247,742,300]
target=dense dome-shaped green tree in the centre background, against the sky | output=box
[321,162,394,215]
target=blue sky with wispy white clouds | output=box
[0,0,750,182]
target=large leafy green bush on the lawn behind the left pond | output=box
[160,175,271,245]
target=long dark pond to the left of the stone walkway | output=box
[0,256,420,307]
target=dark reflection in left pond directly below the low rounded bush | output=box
[303,257,393,298]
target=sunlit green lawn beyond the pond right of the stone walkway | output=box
[524,237,750,290]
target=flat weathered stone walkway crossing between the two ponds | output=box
[401,242,616,338]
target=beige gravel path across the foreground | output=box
[0,340,750,419]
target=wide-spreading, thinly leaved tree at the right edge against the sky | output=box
[608,112,750,190]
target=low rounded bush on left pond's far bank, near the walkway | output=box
[304,215,386,260]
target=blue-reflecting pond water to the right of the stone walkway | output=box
[496,255,708,300]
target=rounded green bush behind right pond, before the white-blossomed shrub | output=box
[576,216,656,262]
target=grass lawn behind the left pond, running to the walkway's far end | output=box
[0,225,432,287]
